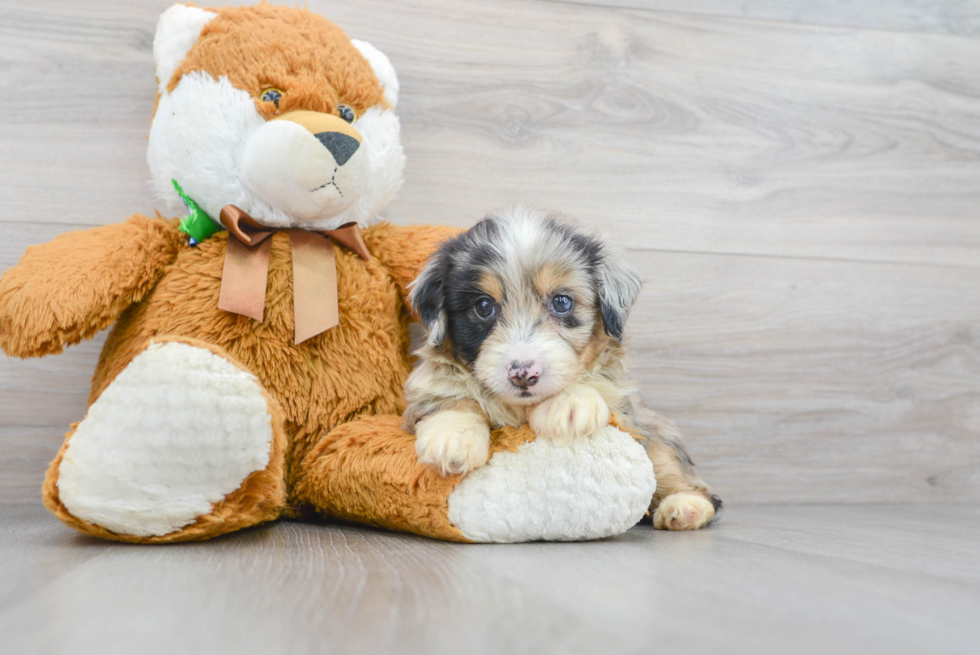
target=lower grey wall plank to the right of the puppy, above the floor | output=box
[631,253,980,503]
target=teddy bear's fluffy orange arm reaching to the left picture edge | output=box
[0,214,184,358]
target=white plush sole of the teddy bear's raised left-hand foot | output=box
[58,342,273,536]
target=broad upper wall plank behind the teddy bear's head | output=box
[0,0,980,266]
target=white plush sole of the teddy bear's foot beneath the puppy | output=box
[449,427,657,543]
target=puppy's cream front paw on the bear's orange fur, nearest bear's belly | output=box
[415,410,490,475]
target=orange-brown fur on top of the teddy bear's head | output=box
[167,4,388,120]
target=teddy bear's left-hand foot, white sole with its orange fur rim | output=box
[43,338,286,542]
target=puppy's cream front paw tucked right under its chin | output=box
[528,384,609,438]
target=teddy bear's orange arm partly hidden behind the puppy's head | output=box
[364,223,463,305]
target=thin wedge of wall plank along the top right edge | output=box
[556,0,980,38]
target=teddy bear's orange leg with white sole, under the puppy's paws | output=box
[295,416,656,543]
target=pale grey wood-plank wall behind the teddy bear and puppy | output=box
[0,0,980,503]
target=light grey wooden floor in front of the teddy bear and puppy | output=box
[0,504,980,655]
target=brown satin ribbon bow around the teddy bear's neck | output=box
[218,205,371,344]
